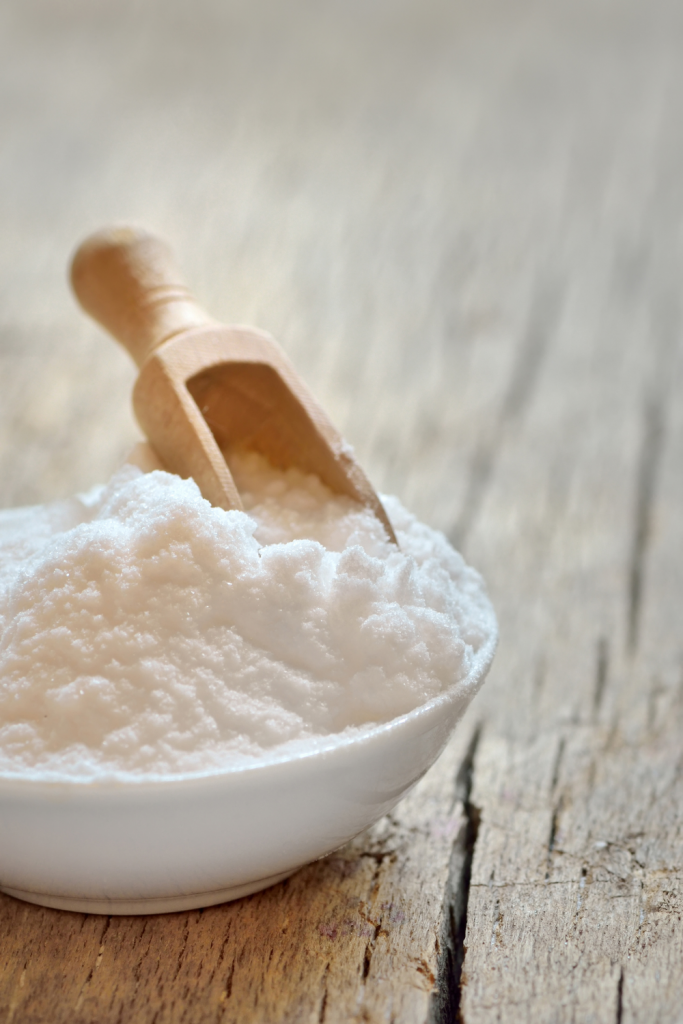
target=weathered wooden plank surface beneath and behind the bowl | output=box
[0,0,683,1024]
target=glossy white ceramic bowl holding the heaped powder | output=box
[0,637,496,913]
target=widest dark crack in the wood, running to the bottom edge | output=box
[429,725,482,1024]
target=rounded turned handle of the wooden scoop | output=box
[71,226,214,367]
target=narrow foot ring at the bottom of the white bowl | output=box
[0,868,296,914]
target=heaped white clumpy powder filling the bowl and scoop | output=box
[0,456,496,779]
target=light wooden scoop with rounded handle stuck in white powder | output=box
[72,227,396,544]
